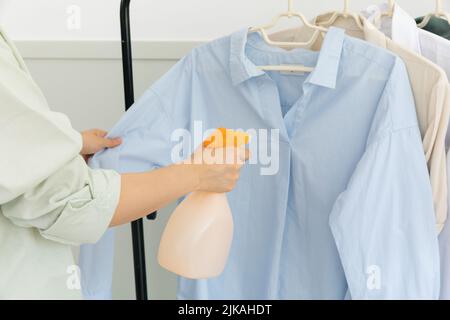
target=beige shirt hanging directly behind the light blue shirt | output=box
[271,14,450,232]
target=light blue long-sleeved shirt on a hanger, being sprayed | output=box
[81,28,440,299]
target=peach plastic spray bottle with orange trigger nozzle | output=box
[158,128,249,279]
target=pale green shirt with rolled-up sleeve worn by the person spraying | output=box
[0,30,120,299]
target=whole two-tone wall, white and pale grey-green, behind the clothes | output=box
[0,0,450,299]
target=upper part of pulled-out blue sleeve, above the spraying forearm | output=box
[90,55,191,173]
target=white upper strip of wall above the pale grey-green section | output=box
[5,0,450,40]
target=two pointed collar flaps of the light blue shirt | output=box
[230,27,345,89]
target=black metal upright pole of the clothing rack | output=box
[120,0,157,300]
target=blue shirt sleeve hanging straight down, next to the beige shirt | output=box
[330,61,439,299]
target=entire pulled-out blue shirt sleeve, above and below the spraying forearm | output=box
[79,56,191,300]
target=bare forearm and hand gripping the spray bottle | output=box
[110,148,249,227]
